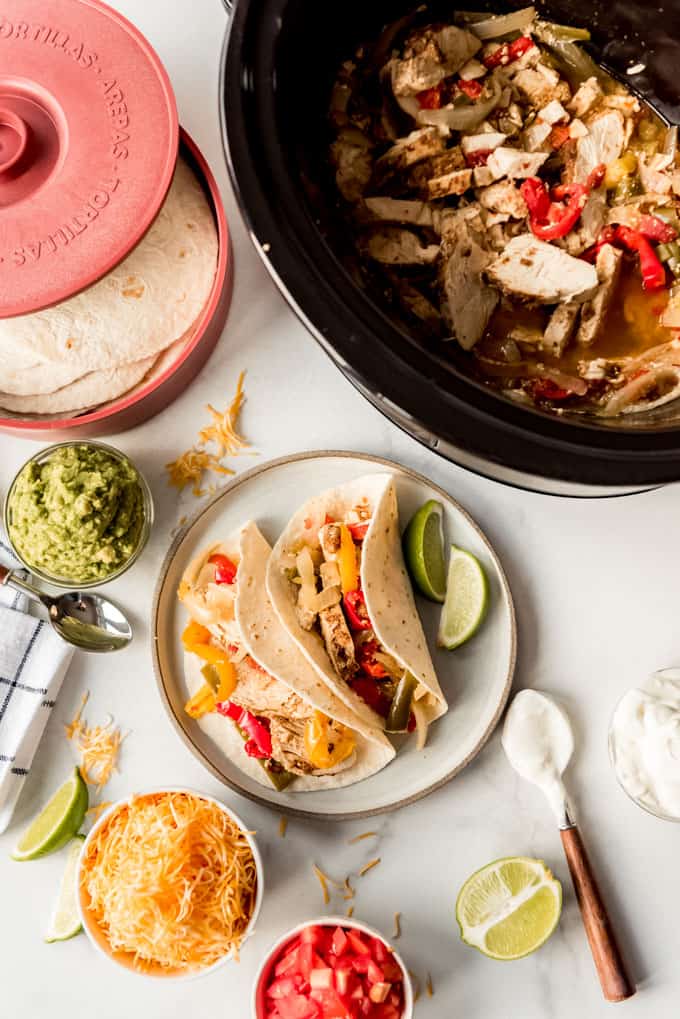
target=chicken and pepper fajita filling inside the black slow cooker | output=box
[330,7,680,418]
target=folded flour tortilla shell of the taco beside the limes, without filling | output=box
[267,474,448,728]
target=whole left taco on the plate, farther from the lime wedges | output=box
[177,521,395,793]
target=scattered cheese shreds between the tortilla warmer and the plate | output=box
[165,372,249,498]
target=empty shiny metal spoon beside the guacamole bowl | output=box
[0,566,133,651]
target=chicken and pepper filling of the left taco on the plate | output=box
[178,552,356,790]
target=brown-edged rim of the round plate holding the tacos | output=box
[151,449,517,822]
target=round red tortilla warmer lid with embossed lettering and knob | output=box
[0,0,178,318]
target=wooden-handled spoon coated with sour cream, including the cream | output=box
[502,690,635,1002]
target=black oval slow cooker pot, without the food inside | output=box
[220,0,680,495]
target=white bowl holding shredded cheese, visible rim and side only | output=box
[75,787,264,980]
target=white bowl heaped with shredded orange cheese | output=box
[76,789,264,979]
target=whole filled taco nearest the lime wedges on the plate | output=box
[267,474,447,746]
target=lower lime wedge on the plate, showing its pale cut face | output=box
[437,545,488,651]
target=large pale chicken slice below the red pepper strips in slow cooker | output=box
[486,233,597,305]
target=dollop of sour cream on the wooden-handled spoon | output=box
[502,690,574,824]
